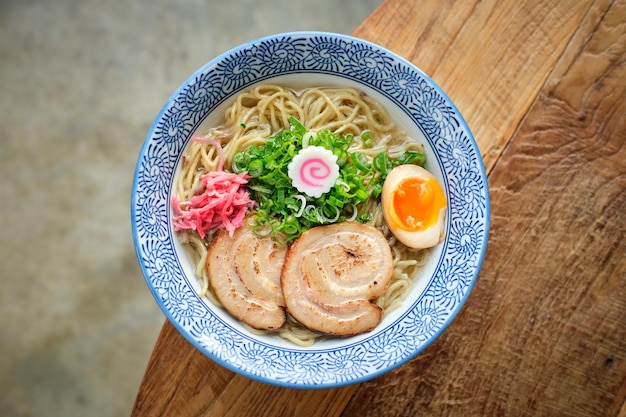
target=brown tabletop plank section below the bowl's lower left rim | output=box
[131,322,357,417]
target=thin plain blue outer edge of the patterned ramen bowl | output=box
[131,31,490,389]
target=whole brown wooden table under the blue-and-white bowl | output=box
[132,0,626,417]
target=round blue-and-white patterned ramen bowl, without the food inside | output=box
[131,32,489,388]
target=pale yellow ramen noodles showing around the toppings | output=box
[174,85,429,346]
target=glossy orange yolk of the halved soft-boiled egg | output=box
[393,177,446,231]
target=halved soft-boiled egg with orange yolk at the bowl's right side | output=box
[382,165,447,249]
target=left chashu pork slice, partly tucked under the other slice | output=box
[207,226,287,330]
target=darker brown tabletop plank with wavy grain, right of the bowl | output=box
[343,2,626,417]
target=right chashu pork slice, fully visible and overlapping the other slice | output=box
[281,222,393,336]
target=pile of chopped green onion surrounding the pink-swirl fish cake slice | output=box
[231,117,424,244]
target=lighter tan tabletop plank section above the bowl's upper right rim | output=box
[355,0,596,172]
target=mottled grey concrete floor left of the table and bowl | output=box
[0,0,381,417]
